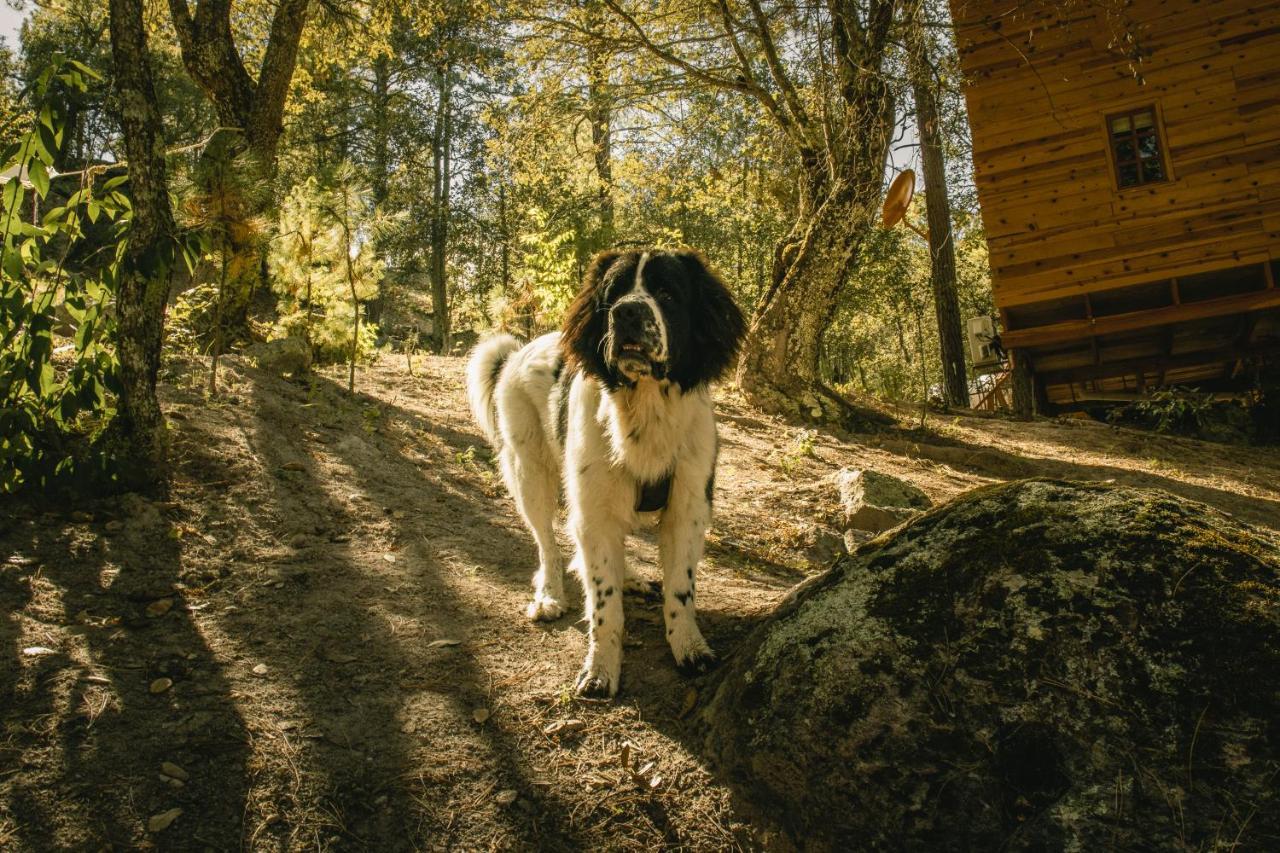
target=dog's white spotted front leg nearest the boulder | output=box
[658,471,716,675]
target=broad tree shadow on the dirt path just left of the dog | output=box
[230,369,585,849]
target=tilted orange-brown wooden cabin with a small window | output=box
[951,0,1280,407]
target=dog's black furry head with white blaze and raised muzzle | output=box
[561,250,746,389]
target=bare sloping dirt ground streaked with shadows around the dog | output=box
[0,356,1280,850]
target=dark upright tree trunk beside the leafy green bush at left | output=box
[106,0,175,482]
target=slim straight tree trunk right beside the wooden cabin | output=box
[906,3,969,409]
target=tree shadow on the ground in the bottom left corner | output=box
[0,494,248,849]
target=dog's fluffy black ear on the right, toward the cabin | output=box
[672,250,746,388]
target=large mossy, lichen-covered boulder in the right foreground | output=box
[699,480,1280,850]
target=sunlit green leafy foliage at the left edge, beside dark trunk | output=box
[0,58,129,492]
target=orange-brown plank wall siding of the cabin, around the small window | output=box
[951,0,1280,307]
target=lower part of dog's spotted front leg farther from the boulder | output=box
[573,529,625,698]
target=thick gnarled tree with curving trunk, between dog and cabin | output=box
[604,0,897,420]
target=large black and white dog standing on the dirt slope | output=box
[467,250,744,697]
